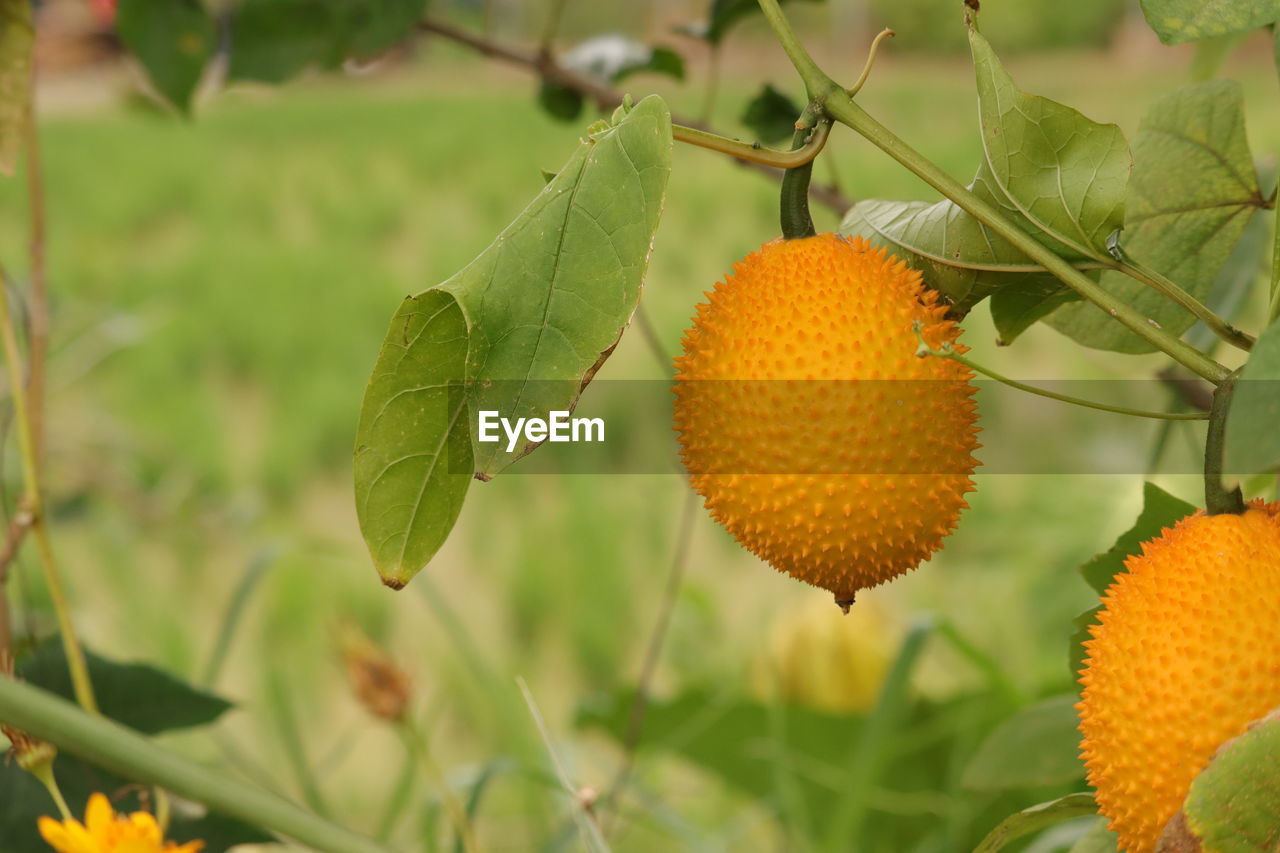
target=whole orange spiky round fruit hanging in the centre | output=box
[676,234,978,602]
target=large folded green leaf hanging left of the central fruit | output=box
[355,97,671,588]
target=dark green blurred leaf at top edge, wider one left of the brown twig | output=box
[227,0,426,83]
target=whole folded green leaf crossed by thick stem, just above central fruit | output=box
[841,29,1129,324]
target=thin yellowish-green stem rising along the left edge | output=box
[0,274,97,713]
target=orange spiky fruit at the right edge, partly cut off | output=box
[1076,501,1280,853]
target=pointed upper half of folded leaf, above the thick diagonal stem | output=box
[969,28,1130,256]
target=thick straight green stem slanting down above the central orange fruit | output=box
[824,95,1230,384]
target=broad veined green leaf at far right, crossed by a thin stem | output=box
[1048,79,1266,352]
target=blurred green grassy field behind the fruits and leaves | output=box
[0,0,1280,853]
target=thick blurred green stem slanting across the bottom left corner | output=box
[0,678,392,853]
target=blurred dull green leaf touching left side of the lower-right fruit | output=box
[964,693,1084,792]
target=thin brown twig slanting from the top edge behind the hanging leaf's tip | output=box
[417,19,854,216]
